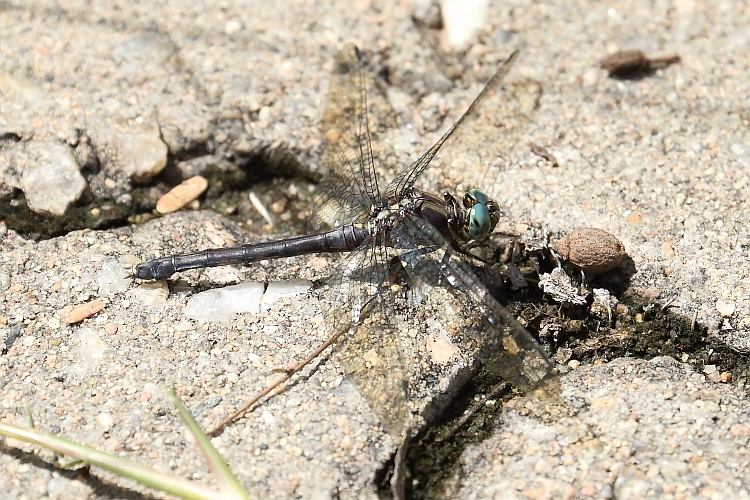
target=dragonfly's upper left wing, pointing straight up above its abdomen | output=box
[311,44,381,228]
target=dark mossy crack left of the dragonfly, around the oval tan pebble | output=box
[0,130,320,241]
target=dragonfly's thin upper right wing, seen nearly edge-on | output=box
[386,51,518,198]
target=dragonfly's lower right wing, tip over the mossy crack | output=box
[391,215,552,389]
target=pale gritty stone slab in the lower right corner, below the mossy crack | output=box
[446,357,750,500]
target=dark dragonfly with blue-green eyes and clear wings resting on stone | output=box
[134,44,554,434]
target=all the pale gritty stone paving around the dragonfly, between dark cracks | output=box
[0,0,750,498]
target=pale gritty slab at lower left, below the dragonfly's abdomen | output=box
[0,216,394,498]
